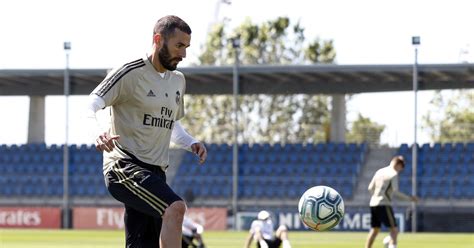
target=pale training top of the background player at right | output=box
[368,166,411,207]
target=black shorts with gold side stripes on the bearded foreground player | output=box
[105,159,182,247]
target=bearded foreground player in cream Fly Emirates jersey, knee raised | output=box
[87,16,207,248]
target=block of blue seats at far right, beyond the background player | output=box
[398,143,474,199]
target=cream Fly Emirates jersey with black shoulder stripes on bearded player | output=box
[92,57,186,172]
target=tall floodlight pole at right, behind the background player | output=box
[411,36,420,233]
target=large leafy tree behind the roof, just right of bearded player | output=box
[184,17,336,143]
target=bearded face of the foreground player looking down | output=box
[158,29,191,71]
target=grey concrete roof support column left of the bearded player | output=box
[27,96,45,143]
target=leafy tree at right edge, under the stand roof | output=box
[422,90,474,142]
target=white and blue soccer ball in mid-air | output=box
[298,186,344,231]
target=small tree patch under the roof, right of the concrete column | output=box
[347,113,385,145]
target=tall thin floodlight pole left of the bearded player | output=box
[63,42,71,229]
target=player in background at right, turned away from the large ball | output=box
[365,156,418,248]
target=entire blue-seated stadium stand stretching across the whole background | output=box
[0,143,474,202]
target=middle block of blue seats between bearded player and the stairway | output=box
[173,143,367,199]
